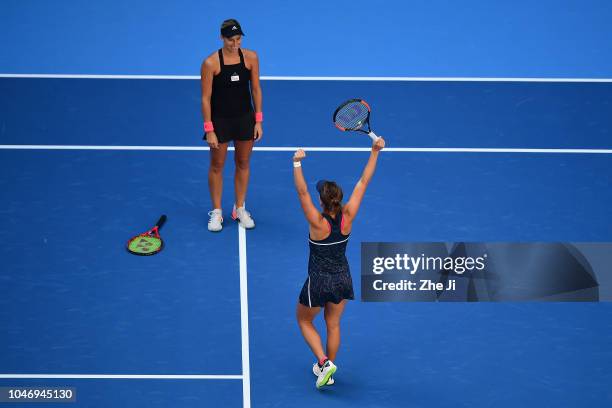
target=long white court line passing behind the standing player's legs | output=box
[0,145,612,154]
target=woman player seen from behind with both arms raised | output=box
[293,138,385,388]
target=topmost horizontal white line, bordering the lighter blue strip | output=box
[0,74,612,83]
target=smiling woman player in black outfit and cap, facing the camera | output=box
[200,19,263,232]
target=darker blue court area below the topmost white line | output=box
[0,78,612,407]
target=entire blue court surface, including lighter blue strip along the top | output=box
[0,0,612,408]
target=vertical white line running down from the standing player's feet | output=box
[238,225,251,408]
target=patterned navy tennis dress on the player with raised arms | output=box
[300,212,355,307]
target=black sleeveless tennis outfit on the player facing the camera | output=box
[210,49,255,143]
